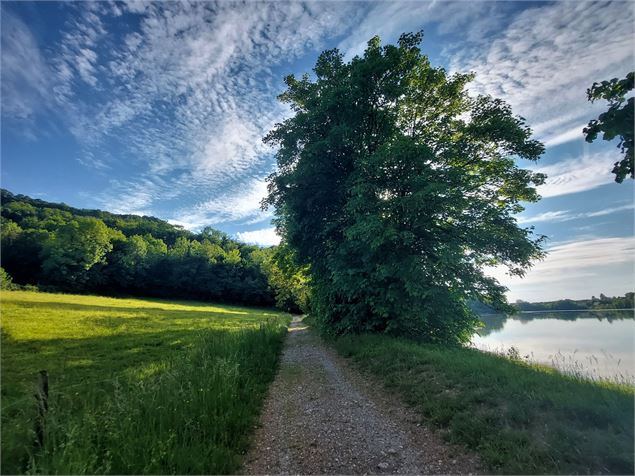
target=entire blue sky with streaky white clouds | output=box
[0,1,635,301]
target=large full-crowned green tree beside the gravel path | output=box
[264,33,544,342]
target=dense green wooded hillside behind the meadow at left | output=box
[1,190,308,312]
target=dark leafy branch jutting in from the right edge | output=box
[583,72,635,183]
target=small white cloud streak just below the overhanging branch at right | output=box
[534,152,616,198]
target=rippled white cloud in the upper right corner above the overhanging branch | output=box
[450,2,635,146]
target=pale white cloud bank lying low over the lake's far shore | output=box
[488,237,635,301]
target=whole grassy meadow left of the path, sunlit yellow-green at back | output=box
[1,291,289,474]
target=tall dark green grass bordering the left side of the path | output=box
[28,324,281,474]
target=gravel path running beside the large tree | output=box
[243,321,478,474]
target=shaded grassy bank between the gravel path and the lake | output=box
[335,336,634,474]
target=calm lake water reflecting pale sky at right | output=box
[472,311,635,383]
